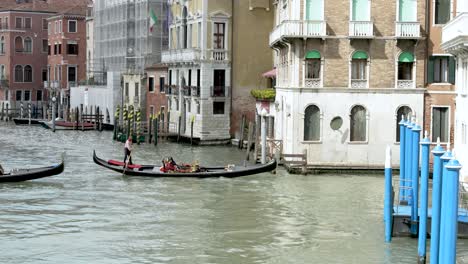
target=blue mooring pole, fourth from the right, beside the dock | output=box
[410,119,421,236]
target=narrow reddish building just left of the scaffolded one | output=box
[44,11,86,109]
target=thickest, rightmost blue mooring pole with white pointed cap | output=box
[439,151,462,263]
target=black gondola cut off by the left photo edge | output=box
[0,160,65,182]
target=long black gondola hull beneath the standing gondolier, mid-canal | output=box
[93,151,276,178]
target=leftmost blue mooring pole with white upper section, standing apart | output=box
[384,146,393,242]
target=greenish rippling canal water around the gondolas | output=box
[0,122,468,264]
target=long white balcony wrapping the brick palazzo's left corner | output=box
[270,20,327,46]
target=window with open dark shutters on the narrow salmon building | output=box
[427,56,455,84]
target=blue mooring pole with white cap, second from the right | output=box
[430,138,445,264]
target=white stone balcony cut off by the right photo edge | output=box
[442,12,468,53]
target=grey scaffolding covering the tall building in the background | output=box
[92,0,168,74]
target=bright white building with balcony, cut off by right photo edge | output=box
[442,1,468,181]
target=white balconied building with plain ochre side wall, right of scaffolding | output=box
[162,0,273,144]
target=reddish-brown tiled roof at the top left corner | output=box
[0,0,92,15]
